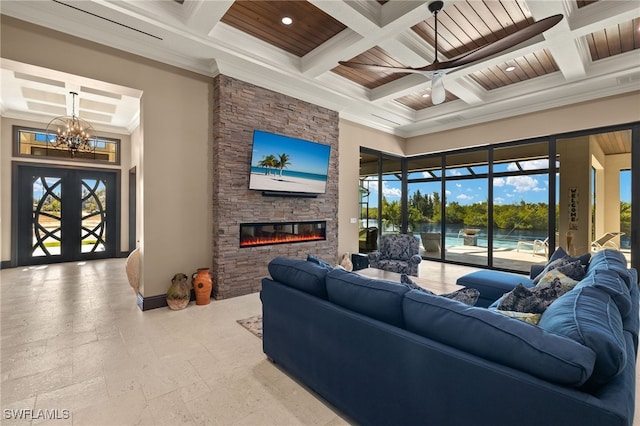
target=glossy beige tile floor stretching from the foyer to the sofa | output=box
[0,259,640,426]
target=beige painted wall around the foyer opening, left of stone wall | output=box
[0,16,212,297]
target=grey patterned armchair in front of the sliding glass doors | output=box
[369,234,422,277]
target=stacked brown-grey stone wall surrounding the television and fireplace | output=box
[211,75,338,299]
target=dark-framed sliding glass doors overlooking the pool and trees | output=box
[361,120,640,273]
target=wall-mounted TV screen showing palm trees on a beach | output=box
[249,130,331,194]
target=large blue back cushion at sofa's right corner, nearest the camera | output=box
[538,286,627,389]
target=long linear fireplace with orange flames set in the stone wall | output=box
[240,221,327,247]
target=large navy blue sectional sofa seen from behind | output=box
[260,250,639,426]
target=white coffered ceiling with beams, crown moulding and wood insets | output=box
[0,0,640,137]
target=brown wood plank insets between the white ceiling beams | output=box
[222,0,640,111]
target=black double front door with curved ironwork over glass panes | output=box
[16,165,118,265]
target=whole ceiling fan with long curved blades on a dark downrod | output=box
[339,1,563,105]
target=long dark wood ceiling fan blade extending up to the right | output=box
[433,14,563,69]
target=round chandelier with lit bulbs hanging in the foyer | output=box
[46,92,96,157]
